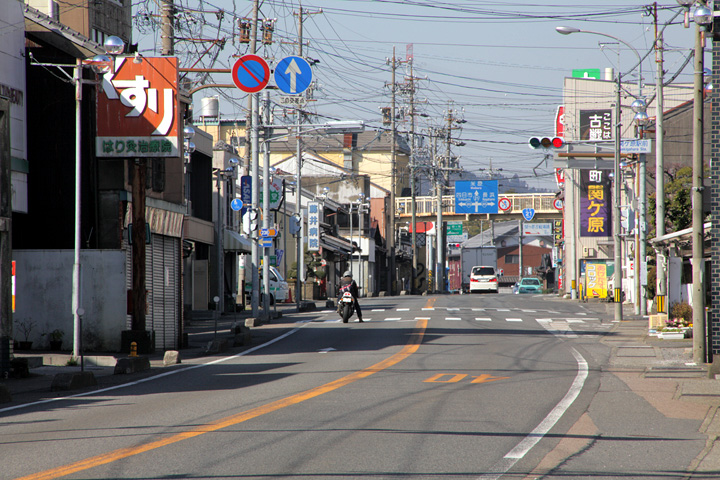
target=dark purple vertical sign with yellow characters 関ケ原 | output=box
[580,170,612,237]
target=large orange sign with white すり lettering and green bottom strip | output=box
[96,57,180,158]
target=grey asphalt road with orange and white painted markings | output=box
[0,294,717,480]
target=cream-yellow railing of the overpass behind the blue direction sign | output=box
[395,193,558,217]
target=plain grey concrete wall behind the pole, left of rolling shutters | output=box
[13,250,127,352]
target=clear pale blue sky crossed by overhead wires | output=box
[133,0,694,189]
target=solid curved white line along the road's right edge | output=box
[477,348,588,480]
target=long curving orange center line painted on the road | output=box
[16,318,435,480]
